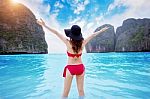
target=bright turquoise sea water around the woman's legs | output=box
[0,53,150,99]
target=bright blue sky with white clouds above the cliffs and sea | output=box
[12,0,150,53]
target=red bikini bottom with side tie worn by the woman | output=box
[63,64,85,77]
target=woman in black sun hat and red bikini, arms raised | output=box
[37,19,108,99]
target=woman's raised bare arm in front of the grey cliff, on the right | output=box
[84,27,108,45]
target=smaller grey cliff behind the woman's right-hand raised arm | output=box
[86,24,115,52]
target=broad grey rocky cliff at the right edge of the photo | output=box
[115,18,150,51]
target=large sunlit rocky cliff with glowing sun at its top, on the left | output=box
[0,0,48,54]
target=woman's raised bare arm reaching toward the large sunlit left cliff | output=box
[37,19,67,44]
